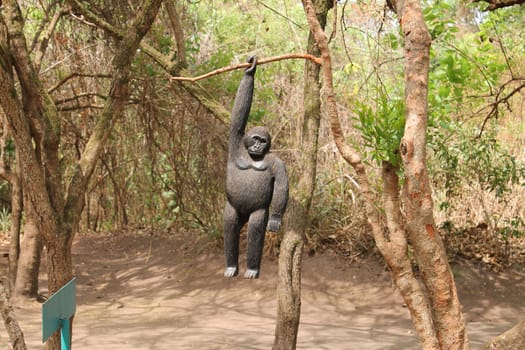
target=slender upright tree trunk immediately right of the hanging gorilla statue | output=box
[273,0,333,350]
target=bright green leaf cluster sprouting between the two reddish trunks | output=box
[354,89,405,167]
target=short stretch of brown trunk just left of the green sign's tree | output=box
[13,205,42,299]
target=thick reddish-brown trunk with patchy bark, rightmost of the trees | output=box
[393,0,468,350]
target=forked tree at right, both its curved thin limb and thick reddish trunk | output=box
[303,0,468,350]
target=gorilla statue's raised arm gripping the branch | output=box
[228,56,257,159]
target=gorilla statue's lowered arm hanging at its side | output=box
[267,157,288,232]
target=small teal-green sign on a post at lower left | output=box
[42,277,77,350]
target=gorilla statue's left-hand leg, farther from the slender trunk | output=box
[224,202,243,277]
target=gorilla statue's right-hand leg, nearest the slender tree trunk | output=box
[244,209,268,278]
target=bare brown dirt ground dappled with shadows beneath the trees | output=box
[0,231,525,350]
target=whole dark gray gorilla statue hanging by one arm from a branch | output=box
[224,57,288,278]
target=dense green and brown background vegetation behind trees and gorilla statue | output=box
[0,0,525,267]
